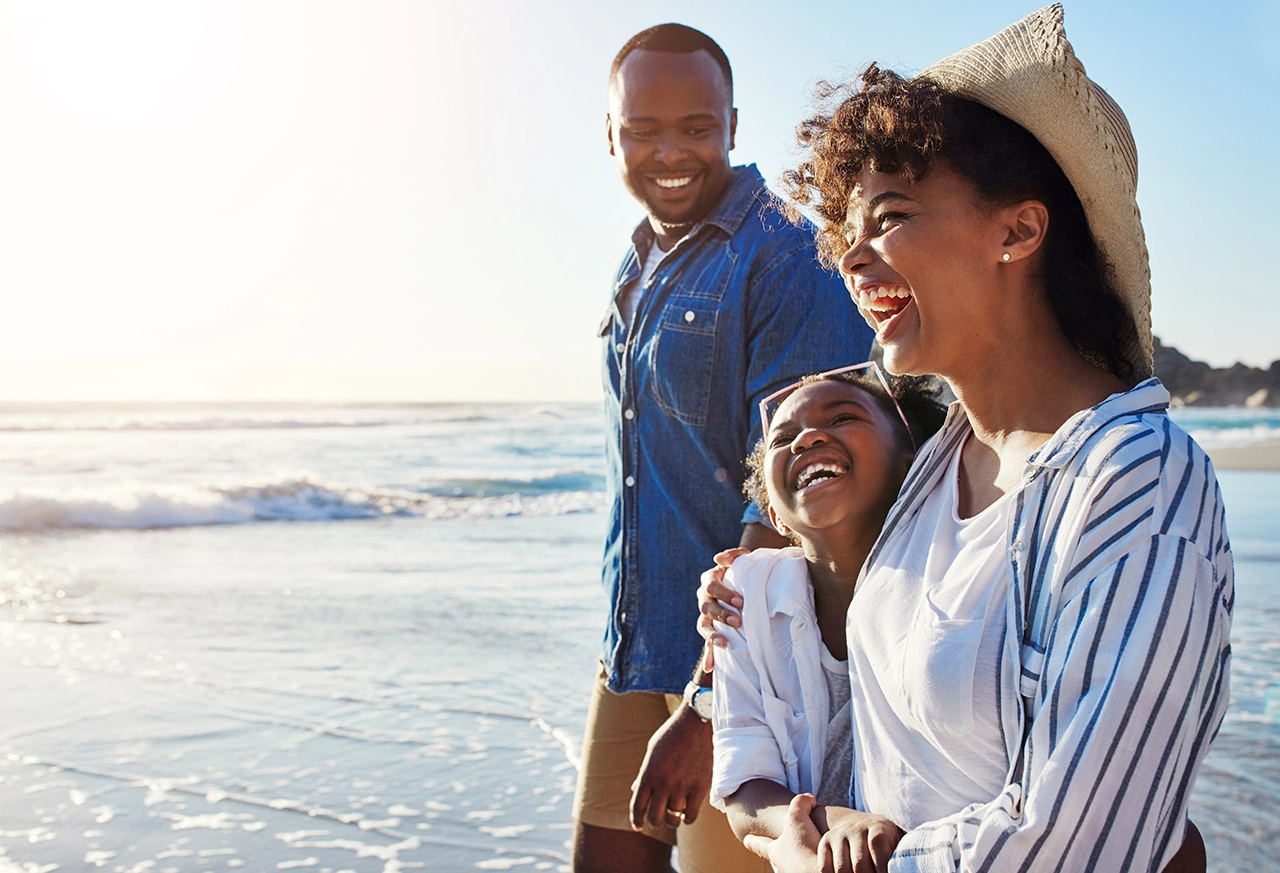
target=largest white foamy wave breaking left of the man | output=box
[0,472,604,530]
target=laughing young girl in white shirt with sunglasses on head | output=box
[710,364,945,869]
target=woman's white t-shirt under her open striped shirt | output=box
[847,437,1018,829]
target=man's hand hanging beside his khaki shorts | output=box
[631,704,712,831]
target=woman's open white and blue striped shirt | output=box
[850,379,1234,873]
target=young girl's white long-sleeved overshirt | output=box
[710,548,831,809]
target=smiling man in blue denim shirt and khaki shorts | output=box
[573,24,870,873]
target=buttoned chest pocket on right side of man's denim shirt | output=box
[649,297,719,428]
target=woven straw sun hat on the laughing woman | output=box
[920,3,1152,380]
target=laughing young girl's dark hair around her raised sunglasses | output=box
[742,372,947,515]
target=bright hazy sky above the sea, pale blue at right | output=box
[0,0,1280,401]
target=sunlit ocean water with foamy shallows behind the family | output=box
[0,403,1280,873]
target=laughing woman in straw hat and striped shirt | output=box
[704,5,1234,872]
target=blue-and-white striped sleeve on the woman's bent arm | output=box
[890,419,1234,873]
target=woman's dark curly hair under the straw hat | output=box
[782,64,1137,381]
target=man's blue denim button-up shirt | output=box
[600,165,872,693]
